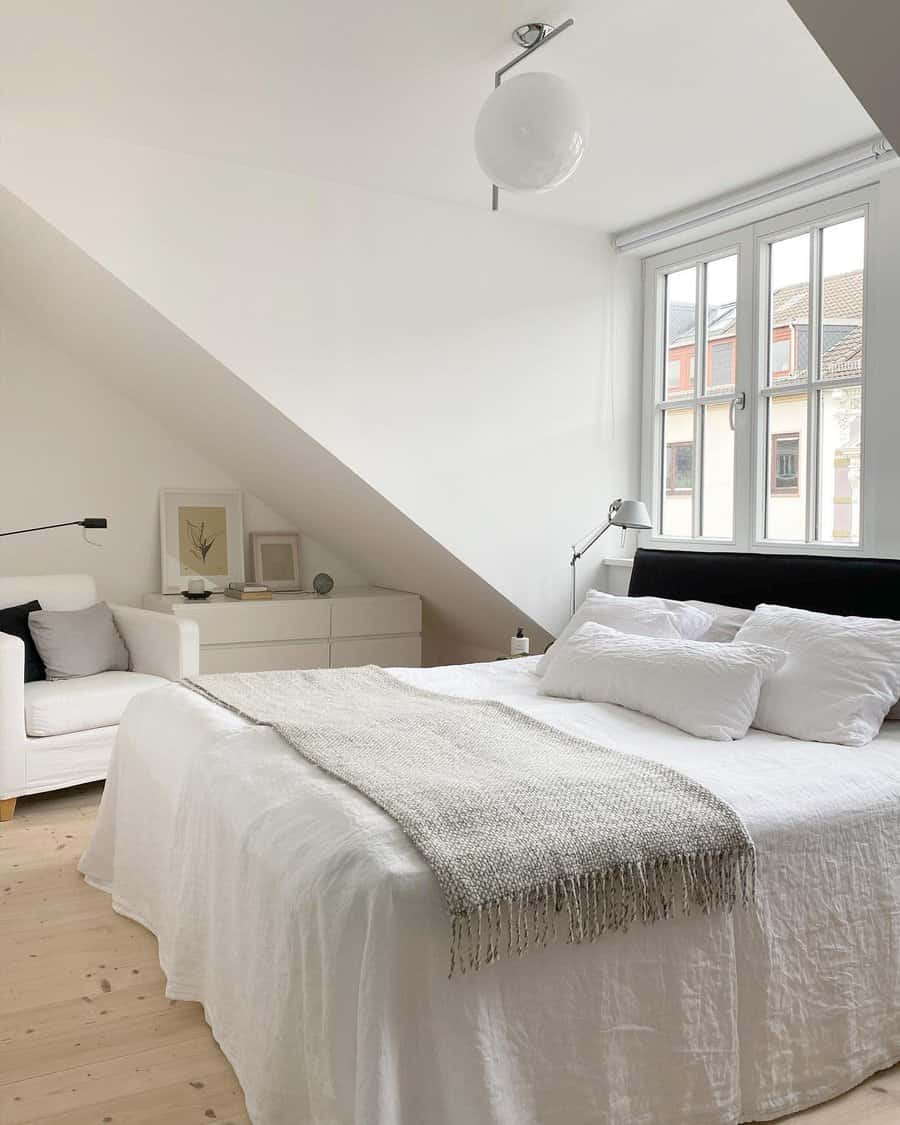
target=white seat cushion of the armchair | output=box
[25,672,169,738]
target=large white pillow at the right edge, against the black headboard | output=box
[737,605,900,746]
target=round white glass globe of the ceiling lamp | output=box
[475,73,588,191]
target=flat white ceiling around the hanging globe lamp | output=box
[0,0,878,231]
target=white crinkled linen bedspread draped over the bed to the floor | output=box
[81,659,900,1125]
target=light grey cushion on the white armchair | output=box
[28,602,128,680]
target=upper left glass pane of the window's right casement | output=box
[768,234,810,385]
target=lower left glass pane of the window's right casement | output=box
[766,395,807,542]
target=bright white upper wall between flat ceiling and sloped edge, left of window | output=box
[0,134,639,629]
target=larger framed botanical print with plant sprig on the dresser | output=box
[160,488,244,594]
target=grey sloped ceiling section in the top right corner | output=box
[790,0,900,156]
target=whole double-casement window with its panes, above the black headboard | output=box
[645,191,869,549]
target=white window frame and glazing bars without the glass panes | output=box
[641,188,875,556]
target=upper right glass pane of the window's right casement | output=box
[821,218,865,379]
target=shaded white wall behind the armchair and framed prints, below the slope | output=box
[0,308,365,604]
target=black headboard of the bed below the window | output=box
[628,548,900,621]
